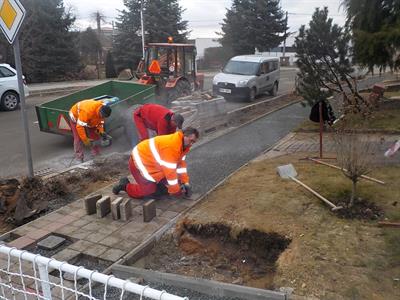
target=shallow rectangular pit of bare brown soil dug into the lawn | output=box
[137,219,290,289]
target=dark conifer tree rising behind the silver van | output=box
[220,0,286,55]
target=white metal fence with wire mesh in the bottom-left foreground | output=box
[0,245,188,300]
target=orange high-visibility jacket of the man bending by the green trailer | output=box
[69,99,104,142]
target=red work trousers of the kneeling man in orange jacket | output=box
[126,157,157,199]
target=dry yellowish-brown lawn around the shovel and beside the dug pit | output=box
[188,154,400,299]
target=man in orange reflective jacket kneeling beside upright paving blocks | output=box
[113,127,199,198]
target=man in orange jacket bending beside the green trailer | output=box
[69,99,111,162]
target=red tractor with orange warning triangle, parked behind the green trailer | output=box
[137,39,204,105]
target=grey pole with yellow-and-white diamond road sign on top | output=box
[0,0,33,177]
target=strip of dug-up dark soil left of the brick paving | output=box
[0,154,129,233]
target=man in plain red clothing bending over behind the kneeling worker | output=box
[133,103,184,142]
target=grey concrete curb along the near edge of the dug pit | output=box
[112,265,287,300]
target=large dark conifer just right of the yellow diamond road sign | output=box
[20,0,80,82]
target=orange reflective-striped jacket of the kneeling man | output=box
[132,131,190,194]
